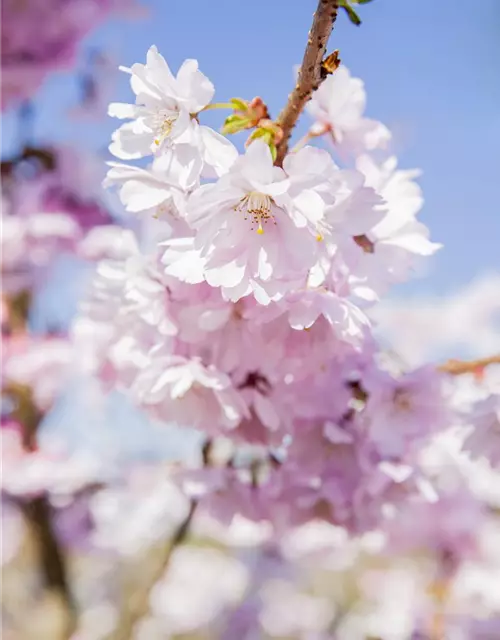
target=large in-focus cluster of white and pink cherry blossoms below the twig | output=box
[85,47,451,532]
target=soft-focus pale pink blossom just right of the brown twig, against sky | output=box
[307,66,391,155]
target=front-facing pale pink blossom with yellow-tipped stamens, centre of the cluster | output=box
[187,140,324,304]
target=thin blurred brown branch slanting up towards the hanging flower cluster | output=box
[109,500,198,640]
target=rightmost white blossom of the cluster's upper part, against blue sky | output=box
[316,155,441,304]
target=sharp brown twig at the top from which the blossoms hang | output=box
[275,0,338,166]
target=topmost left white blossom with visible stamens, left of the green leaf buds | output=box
[109,46,237,175]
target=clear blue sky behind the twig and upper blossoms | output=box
[4,0,500,294]
